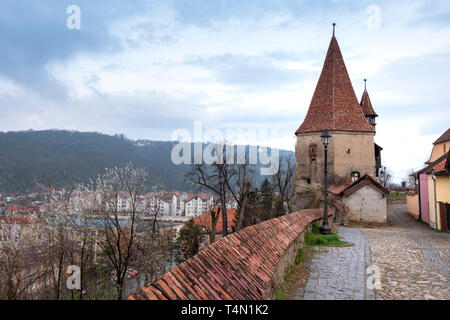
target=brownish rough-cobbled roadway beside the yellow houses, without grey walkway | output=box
[361,205,450,300]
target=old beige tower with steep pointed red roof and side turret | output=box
[295,26,382,209]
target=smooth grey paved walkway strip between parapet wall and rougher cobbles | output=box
[294,228,374,300]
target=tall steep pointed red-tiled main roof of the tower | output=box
[295,35,374,134]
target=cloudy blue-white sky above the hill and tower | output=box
[0,0,450,181]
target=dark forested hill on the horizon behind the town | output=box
[0,130,293,192]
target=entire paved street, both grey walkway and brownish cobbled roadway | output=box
[294,205,450,300]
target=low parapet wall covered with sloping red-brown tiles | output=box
[129,209,333,300]
